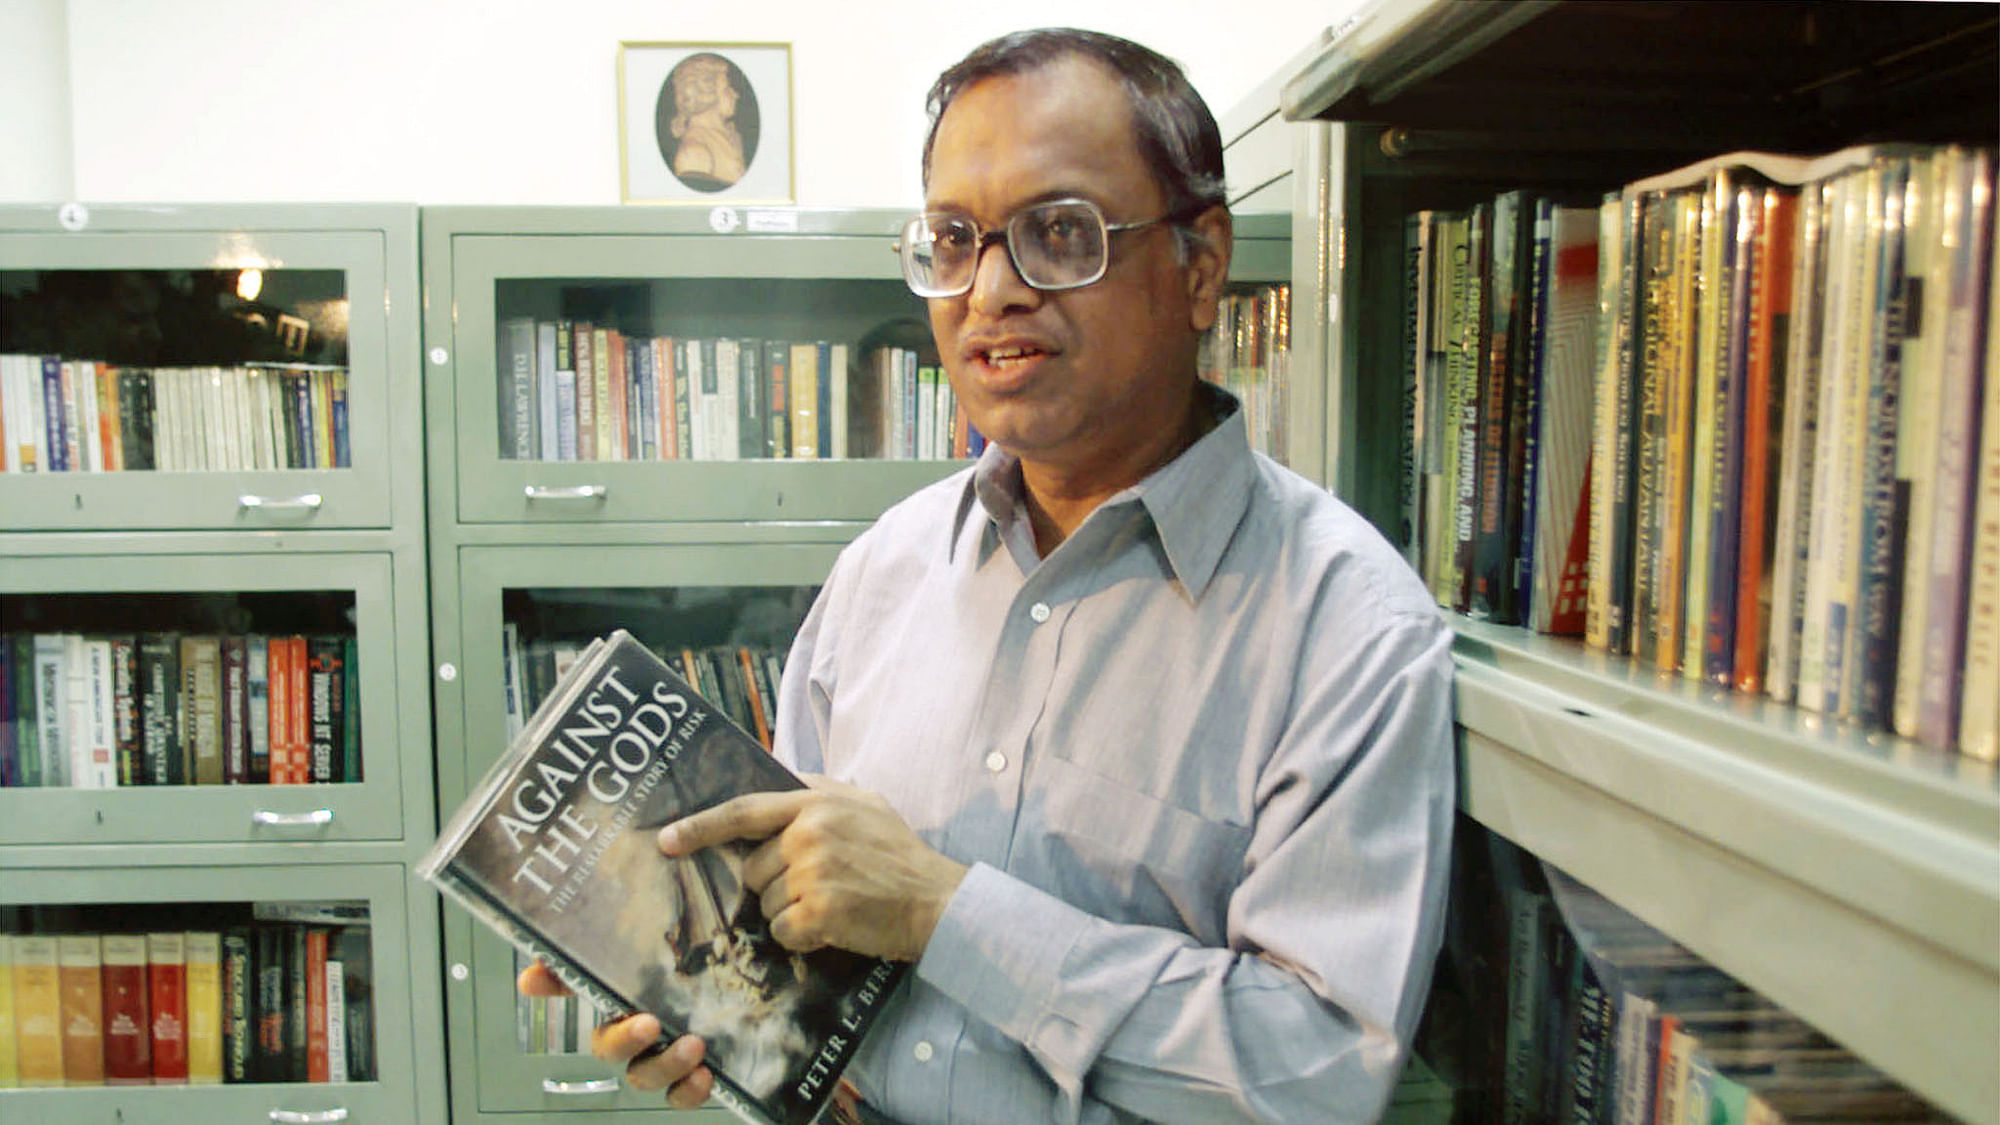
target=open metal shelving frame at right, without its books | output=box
[1280,0,2000,1123]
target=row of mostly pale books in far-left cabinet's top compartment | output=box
[0,354,350,472]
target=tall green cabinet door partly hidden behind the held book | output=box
[440,528,852,1119]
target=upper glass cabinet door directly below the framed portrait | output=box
[434,210,980,522]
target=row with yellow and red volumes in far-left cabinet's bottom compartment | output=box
[0,921,374,1089]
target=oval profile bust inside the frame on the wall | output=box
[654,52,760,192]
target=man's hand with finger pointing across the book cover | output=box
[660,777,966,961]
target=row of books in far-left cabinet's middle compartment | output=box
[0,633,362,789]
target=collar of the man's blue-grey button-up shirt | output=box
[946,380,1256,601]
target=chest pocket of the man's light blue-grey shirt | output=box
[1008,757,1250,945]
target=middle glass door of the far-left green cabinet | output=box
[0,550,410,843]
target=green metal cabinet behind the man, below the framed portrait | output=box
[422,208,1288,1121]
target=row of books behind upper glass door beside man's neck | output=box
[496,316,972,460]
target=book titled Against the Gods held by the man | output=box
[418,631,902,1125]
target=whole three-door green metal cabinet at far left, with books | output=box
[0,204,446,1123]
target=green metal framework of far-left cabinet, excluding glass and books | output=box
[0,204,448,1125]
